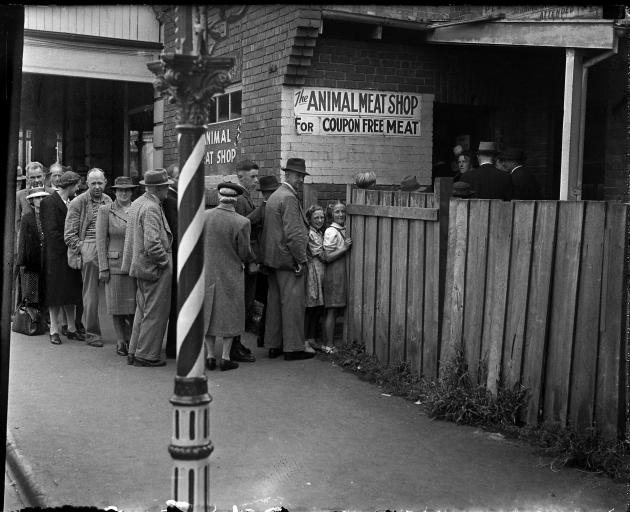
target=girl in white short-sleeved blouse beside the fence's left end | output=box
[324,201,352,347]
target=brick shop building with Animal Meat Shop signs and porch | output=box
[157,4,625,203]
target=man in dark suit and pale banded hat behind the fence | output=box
[460,141,512,201]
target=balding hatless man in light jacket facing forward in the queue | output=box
[63,167,112,347]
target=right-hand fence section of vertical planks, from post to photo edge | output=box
[441,199,627,437]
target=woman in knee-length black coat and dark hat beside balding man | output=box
[41,171,85,345]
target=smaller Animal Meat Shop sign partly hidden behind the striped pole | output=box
[204,119,241,176]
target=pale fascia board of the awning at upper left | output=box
[22,30,162,83]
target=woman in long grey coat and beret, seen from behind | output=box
[203,182,254,371]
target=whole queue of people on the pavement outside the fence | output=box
[15,158,352,371]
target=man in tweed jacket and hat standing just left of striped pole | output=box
[122,169,173,367]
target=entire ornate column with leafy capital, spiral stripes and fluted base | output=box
[147,5,234,512]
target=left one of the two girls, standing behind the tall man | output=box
[304,204,326,352]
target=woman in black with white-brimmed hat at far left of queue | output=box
[15,187,50,304]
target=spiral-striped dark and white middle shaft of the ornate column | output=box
[177,131,205,377]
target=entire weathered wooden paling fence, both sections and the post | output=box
[345,190,628,438]
